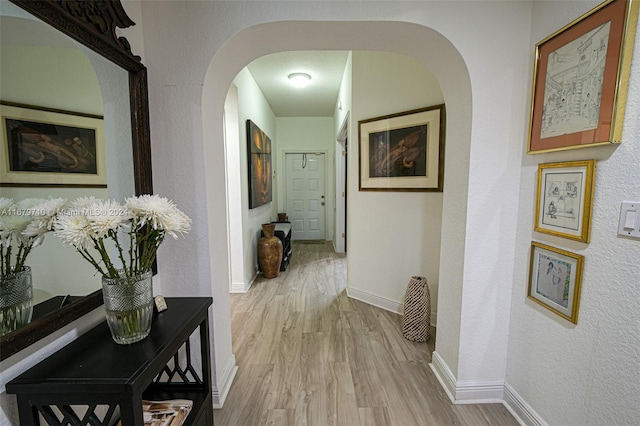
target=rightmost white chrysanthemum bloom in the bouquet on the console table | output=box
[126,195,191,238]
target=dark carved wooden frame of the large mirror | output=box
[0,0,153,360]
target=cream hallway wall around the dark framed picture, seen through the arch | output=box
[347,51,446,322]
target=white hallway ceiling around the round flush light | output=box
[247,50,349,117]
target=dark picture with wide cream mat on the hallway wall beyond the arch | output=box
[358,105,445,192]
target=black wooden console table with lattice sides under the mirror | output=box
[6,297,213,426]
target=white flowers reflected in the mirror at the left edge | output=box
[0,198,67,276]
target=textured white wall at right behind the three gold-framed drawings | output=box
[506,1,640,426]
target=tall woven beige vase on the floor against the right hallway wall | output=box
[402,277,431,342]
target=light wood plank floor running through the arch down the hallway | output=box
[214,243,517,426]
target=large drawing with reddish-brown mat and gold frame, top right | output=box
[527,0,638,154]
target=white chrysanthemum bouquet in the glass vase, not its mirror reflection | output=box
[53,195,191,278]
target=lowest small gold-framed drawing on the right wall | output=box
[527,241,584,324]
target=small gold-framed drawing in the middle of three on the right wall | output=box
[534,160,596,243]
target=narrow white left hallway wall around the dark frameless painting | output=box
[234,69,278,286]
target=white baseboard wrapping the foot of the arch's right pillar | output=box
[429,352,504,404]
